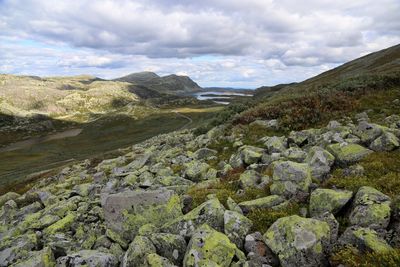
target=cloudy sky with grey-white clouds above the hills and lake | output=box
[0,0,400,88]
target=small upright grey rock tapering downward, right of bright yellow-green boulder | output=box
[224,210,253,248]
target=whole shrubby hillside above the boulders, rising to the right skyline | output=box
[235,45,400,131]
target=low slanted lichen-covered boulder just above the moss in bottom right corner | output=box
[339,226,392,253]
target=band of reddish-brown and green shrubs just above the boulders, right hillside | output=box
[233,73,400,131]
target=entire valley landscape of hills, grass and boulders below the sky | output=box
[0,45,400,267]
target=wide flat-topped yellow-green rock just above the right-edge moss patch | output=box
[328,143,372,166]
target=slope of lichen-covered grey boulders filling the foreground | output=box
[0,108,400,266]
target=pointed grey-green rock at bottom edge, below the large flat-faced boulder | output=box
[121,236,156,267]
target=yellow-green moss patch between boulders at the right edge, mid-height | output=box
[324,150,400,197]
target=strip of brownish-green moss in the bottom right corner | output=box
[331,246,400,267]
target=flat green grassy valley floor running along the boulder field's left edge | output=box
[0,107,220,194]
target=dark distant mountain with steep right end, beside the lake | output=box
[115,72,202,94]
